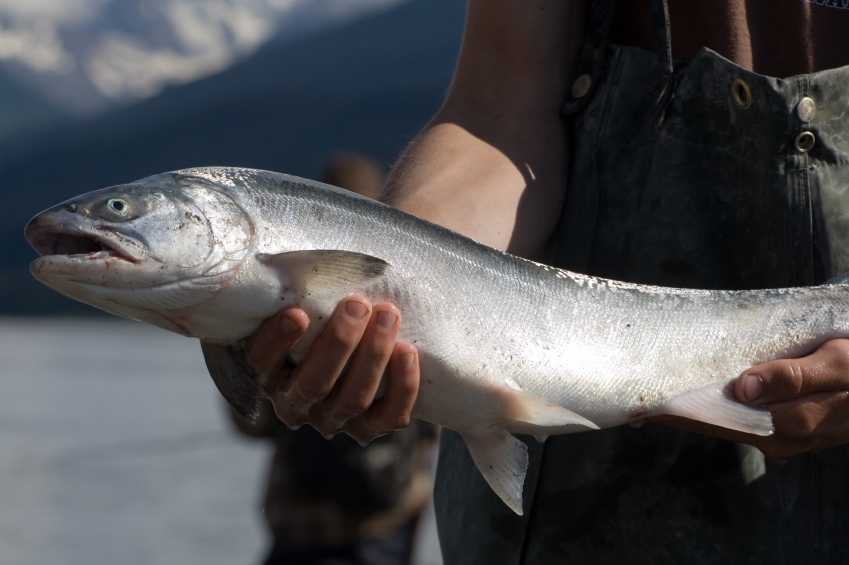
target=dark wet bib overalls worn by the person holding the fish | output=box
[436,0,849,565]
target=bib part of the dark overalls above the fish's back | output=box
[558,47,849,289]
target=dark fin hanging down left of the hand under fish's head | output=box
[200,340,263,422]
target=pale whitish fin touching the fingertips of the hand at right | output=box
[653,383,775,436]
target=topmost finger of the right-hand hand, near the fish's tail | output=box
[734,339,849,404]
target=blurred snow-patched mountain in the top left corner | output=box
[0,0,407,115]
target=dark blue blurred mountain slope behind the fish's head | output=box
[0,0,465,313]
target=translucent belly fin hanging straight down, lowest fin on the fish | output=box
[460,426,528,516]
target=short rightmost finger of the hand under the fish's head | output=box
[348,343,420,441]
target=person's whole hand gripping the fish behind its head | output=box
[245,295,419,444]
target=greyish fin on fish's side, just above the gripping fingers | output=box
[256,250,389,299]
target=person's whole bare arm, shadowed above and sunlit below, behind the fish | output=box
[382,0,584,256]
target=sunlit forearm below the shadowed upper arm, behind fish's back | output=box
[383,114,567,256]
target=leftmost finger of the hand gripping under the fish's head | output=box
[245,306,310,375]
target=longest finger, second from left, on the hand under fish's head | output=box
[282,295,371,416]
